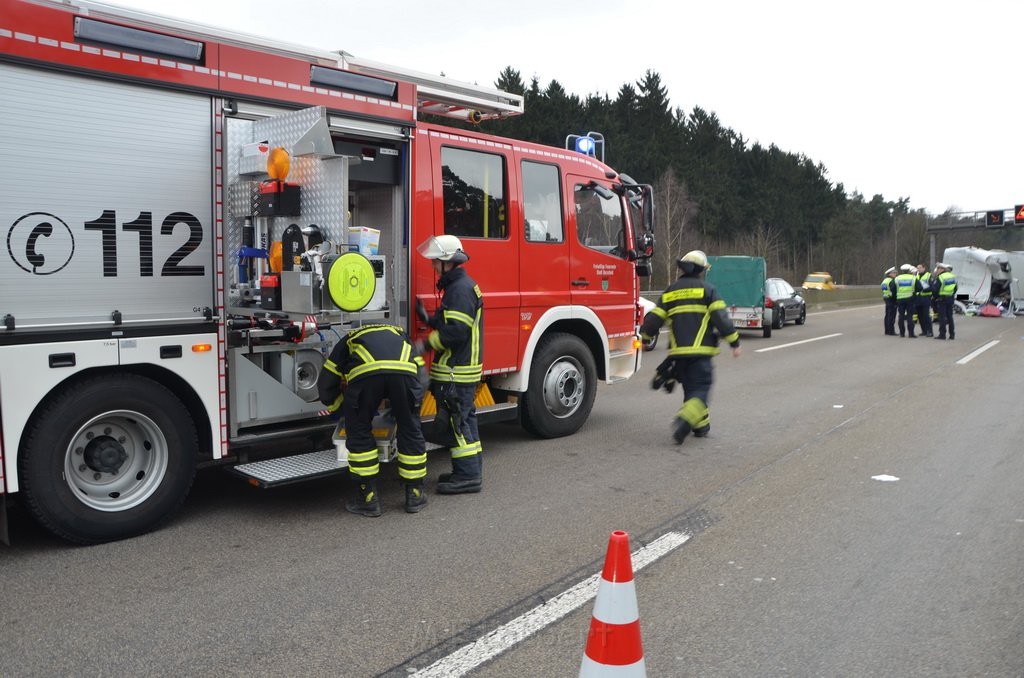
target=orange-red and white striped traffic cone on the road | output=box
[580,531,647,678]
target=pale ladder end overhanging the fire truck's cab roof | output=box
[339,51,523,123]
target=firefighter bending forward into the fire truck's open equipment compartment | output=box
[316,325,427,517]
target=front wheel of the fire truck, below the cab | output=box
[522,333,597,438]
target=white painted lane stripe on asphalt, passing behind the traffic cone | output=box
[411,532,690,678]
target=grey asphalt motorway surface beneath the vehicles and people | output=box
[0,306,1024,677]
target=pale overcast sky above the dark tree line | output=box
[108,0,1024,214]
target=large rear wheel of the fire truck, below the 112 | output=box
[18,375,199,544]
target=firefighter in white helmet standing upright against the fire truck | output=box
[417,235,483,495]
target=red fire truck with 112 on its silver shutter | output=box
[0,0,653,543]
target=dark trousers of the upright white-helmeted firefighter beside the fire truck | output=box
[427,381,483,481]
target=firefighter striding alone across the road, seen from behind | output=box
[640,250,740,443]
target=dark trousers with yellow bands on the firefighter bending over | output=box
[341,374,427,486]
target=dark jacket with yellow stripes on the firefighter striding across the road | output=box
[640,276,739,355]
